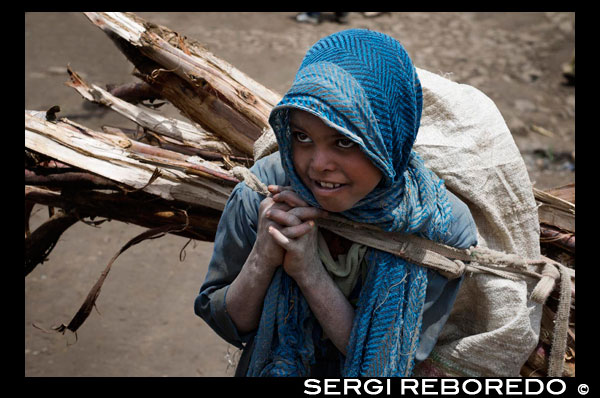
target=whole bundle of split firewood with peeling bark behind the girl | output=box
[25,13,575,376]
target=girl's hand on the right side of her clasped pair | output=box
[267,186,327,282]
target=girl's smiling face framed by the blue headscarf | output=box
[290,109,382,213]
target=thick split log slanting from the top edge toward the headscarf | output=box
[85,13,281,155]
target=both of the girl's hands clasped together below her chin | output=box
[257,185,327,282]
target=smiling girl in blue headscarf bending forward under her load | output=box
[195,29,477,377]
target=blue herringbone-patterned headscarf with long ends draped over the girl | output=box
[248,29,451,377]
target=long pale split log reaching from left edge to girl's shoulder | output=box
[25,111,237,210]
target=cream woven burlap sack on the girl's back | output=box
[414,69,542,376]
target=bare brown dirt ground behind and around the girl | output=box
[24,12,575,377]
